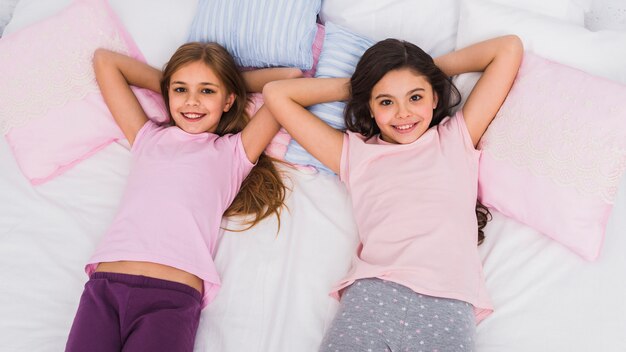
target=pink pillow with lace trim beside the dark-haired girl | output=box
[479,53,626,260]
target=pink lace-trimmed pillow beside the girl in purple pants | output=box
[0,0,167,184]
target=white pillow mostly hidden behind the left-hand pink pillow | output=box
[4,0,198,68]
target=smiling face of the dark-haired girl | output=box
[369,68,437,144]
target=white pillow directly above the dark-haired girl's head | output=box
[320,0,459,56]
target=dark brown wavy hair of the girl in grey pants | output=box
[344,38,491,244]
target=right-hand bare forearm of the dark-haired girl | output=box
[434,35,523,76]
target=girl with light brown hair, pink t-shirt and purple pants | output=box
[66,42,301,351]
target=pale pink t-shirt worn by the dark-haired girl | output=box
[331,113,493,321]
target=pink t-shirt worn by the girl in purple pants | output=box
[85,121,254,307]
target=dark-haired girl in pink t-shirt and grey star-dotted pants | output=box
[263,36,523,351]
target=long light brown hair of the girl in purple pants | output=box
[161,42,286,229]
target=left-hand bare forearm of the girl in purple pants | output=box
[93,49,162,93]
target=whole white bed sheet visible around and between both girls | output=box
[0,129,626,352]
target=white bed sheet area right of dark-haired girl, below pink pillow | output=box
[477,194,626,352]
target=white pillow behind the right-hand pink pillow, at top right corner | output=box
[457,0,626,84]
